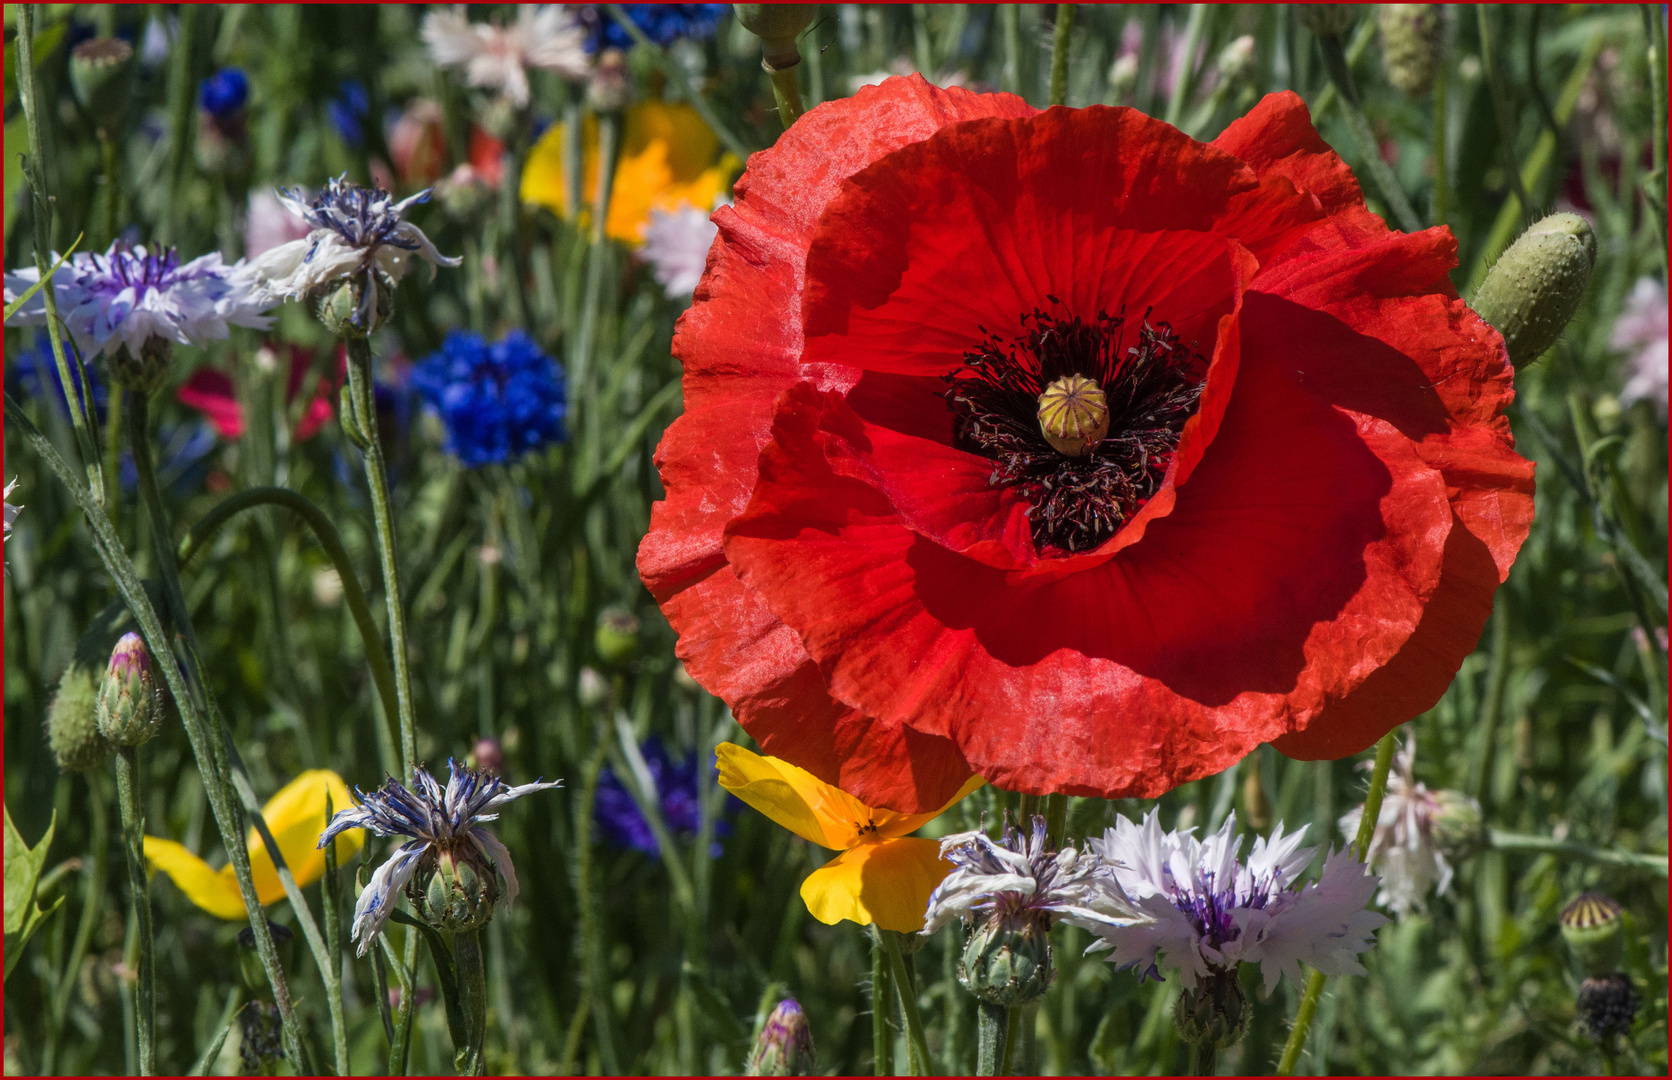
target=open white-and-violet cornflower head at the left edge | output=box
[5,241,273,359]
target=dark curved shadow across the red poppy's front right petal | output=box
[906,304,1424,706]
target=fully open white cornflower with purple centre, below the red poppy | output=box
[1087,811,1388,993]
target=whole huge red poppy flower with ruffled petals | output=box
[639,77,1533,813]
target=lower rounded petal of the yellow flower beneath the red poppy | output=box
[801,836,951,933]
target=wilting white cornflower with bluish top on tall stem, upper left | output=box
[247,177,461,328]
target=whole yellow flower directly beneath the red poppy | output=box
[716,742,985,931]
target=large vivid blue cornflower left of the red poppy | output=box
[411,329,568,466]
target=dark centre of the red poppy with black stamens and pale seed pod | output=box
[945,304,1207,555]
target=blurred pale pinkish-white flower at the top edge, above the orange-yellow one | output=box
[420,3,587,109]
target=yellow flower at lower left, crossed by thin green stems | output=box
[145,769,366,920]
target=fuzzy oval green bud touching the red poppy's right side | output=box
[1470,212,1597,369]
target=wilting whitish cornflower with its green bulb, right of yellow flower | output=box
[923,816,1145,1006]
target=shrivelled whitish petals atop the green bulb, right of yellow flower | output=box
[923,818,1144,935]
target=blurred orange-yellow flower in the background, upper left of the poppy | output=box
[522,100,742,244]
